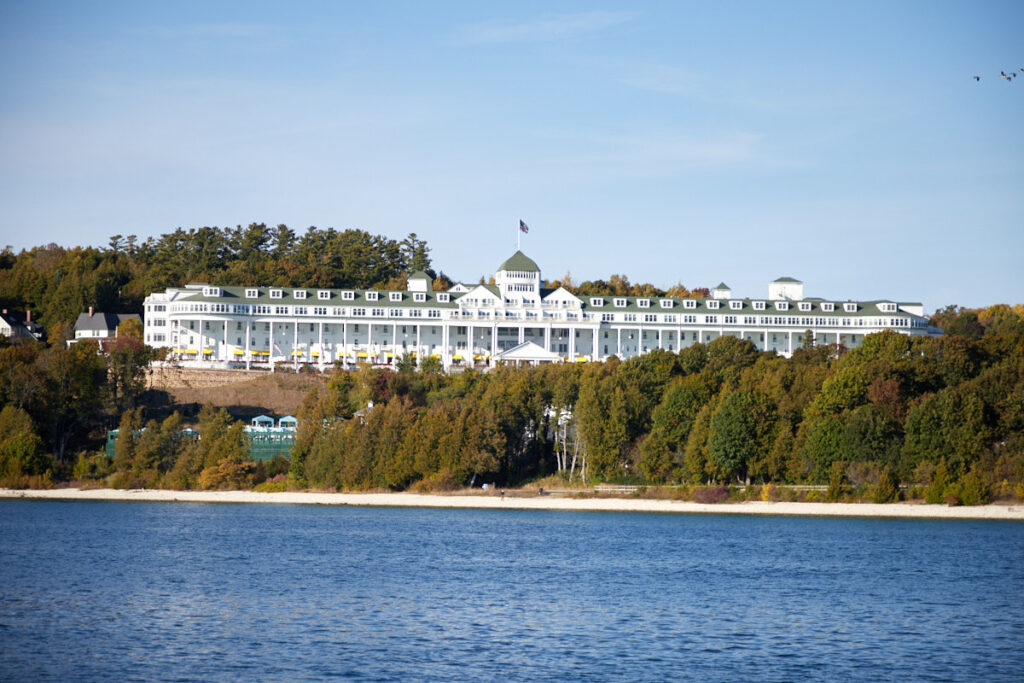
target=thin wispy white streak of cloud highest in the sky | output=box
[458,11,636,45]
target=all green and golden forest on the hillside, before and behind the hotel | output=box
[0,225,1024,503]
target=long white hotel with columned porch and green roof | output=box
[144,252,941,369]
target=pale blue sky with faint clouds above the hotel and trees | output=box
[0,0,1024,311]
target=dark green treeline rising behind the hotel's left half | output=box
[0,223,443,334]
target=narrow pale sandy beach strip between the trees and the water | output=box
[0,488,1024,521]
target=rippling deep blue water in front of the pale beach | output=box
[0,501,1024,681]
